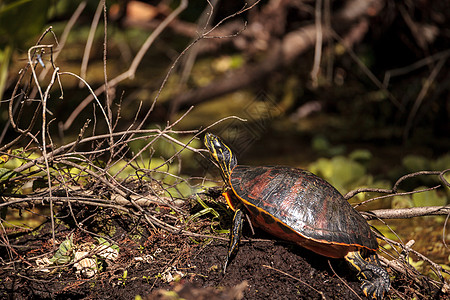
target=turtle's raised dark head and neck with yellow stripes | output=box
[204,133,237,180]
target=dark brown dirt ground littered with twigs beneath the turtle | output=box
[0,209,448,300]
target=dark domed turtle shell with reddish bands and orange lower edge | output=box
[229,165,378,258]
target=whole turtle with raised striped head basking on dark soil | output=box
[204,133,390,299]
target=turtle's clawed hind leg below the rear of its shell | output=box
[345,251,391,300]
